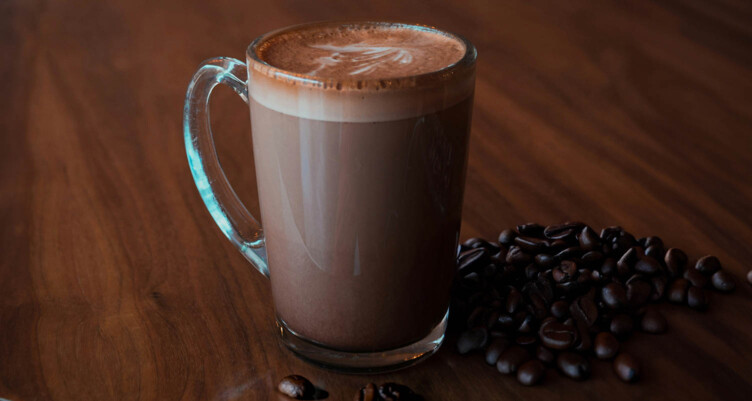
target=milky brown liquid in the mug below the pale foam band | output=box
[251,95,472,351]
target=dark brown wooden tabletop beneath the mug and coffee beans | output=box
[0,0,752,401]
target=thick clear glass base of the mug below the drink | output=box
[277,309,449,374]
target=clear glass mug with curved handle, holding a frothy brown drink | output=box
[184,22,477,372]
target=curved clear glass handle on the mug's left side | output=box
[183,57,269,278]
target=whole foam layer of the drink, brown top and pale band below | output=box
[247,23,475,122]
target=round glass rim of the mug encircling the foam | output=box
[246,20,478,90]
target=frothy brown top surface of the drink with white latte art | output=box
[259,25,465,79]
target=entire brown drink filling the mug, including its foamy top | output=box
[248,23,474,351]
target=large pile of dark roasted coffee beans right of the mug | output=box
[450,222,736,385]
